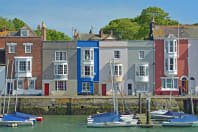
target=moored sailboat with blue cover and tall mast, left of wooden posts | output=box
[87,59,139,127]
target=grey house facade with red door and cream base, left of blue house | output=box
[42,41,77,96]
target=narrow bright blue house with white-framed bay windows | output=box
[77,41,99,95]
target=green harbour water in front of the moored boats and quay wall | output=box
[0,115,198,132]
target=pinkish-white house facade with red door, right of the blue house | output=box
[99,41,128,96]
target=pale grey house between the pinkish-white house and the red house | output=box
[125,40,154,95]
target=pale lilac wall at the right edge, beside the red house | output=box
[188,39,198,94]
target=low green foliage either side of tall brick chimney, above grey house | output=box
[34,29,72,40]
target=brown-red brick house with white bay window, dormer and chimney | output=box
[0,23,46,95]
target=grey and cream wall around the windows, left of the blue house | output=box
[42,41,77,96]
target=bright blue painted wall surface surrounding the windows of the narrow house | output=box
[77,41,99,95]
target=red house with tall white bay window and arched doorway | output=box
[152,24,189,95]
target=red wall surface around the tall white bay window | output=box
[154,40,188,95]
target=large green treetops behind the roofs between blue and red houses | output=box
[102,7,178,40]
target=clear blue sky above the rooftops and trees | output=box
[0,0,198,37]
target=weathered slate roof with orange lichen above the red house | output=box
[153,25,198,39]
